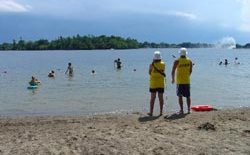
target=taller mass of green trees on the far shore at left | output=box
[0,35,139,50]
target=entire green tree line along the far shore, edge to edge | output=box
[0,35,250,50]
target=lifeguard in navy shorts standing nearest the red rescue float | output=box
[172,48,193,114]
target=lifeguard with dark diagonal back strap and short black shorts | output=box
[148,51,166,116]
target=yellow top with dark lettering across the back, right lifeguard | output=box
[176,57,192,84]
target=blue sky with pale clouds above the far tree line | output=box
[0,0,250,44]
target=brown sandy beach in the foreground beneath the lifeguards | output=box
[0,108,250,155]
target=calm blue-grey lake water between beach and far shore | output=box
[0,49,250,116]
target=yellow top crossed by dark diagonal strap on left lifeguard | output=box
[150,61,165,88]
